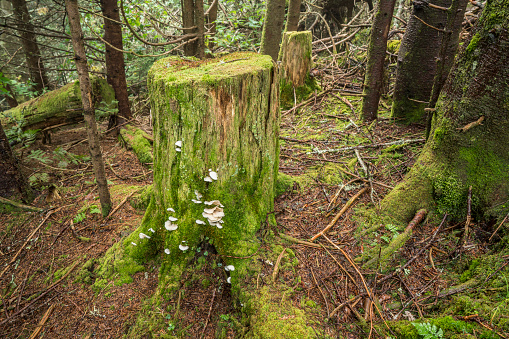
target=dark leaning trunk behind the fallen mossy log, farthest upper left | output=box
[11,0,48,92]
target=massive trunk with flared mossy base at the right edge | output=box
[382,0,509,224]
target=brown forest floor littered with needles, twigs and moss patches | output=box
[0,65,509,338]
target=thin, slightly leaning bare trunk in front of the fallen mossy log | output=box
[65,0,111,216]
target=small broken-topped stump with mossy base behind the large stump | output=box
[279,31,318,107]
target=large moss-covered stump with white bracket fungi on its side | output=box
[103,53,314,338]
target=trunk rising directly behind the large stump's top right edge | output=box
[260,0,285,61]
